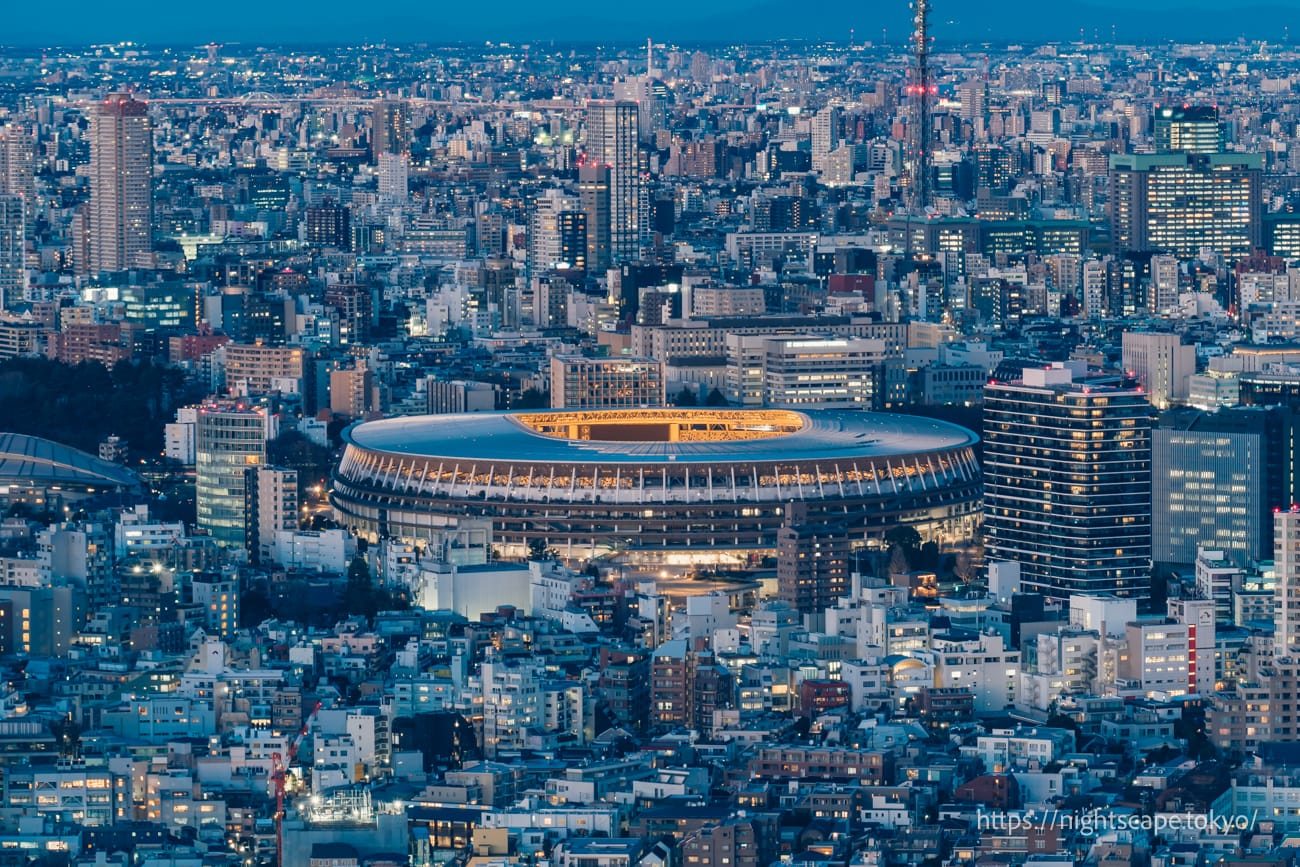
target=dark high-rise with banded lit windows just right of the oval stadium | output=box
[984,364,1151,598]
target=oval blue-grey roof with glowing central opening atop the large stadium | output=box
[343,407,979,464]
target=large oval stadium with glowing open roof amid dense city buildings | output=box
[332,408,980,567]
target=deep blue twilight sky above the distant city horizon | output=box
[0,0,1300,45]
